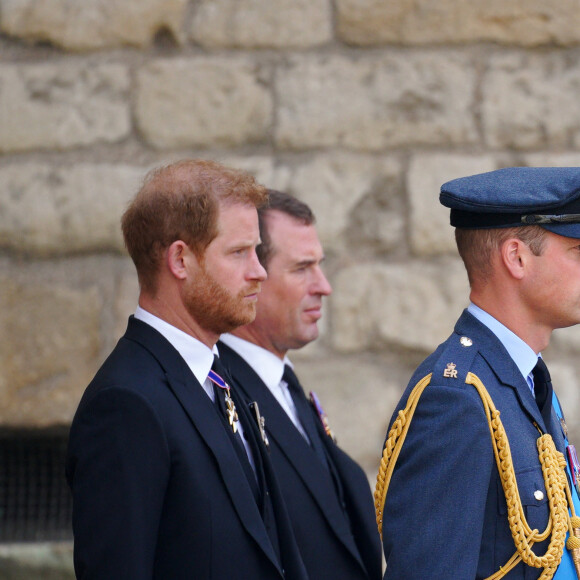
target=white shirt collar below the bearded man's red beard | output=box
[135,306,217,398]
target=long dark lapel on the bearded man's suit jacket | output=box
[126,317,280,568]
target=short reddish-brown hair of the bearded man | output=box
[121,159,267,293]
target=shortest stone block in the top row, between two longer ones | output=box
[191,0,332,48]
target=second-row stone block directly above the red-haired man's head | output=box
[136,58,272,148]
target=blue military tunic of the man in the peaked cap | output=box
[383,311,574,580]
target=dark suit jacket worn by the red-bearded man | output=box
[67,317,306,580]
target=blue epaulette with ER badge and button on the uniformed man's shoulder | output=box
[431,334,478,387]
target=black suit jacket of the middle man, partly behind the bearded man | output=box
[218,342,382,580]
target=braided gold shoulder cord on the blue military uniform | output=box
[374,373,580,580]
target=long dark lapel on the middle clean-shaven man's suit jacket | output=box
[218,342,364,567]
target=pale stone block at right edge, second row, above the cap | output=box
[481,52,580,149]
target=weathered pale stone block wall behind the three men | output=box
[0,0,580,578]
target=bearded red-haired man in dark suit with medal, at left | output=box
[67,160,307,580]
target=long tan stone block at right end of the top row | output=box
[336,0,580,46]
